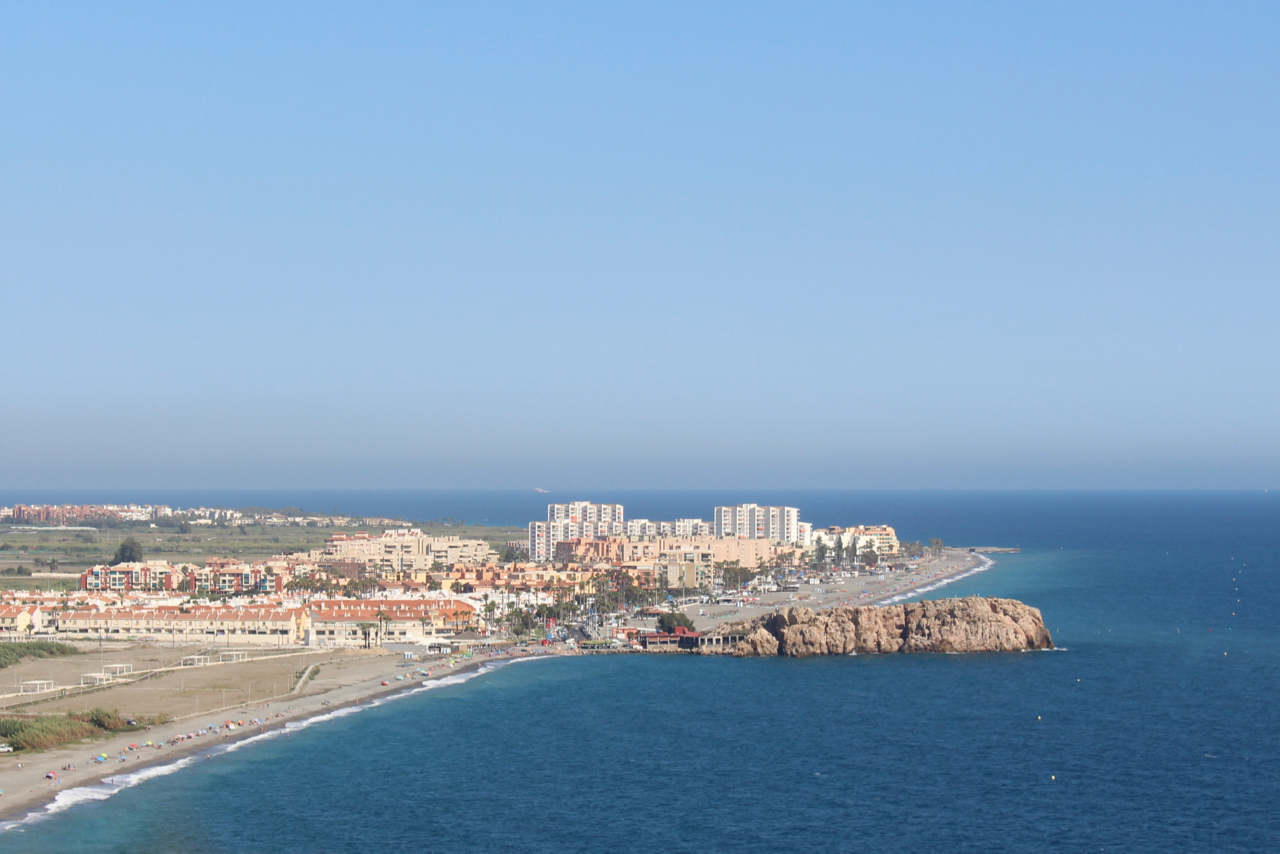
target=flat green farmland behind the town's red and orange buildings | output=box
[0,524,527,573]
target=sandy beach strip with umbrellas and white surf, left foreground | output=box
[0,652,556,839]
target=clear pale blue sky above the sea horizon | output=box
[0,0,1280,489]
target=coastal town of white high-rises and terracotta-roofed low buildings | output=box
[0,502,962,649]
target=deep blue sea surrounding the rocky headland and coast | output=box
[0,493,1280,851]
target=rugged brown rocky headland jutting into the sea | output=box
[704,597,1053,657]
